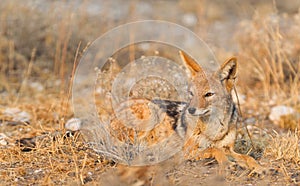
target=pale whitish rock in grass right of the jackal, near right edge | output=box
[269,105,295,124]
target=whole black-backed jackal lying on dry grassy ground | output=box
[106,51,262,185]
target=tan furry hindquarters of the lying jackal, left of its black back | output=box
[110,99,175,145]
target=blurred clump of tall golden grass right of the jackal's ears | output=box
[237,13,300,103]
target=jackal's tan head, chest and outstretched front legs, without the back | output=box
[179,52,262,172]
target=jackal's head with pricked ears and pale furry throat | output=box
[179,51,237,140]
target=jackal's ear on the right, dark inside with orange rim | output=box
[218,57,237,92]
